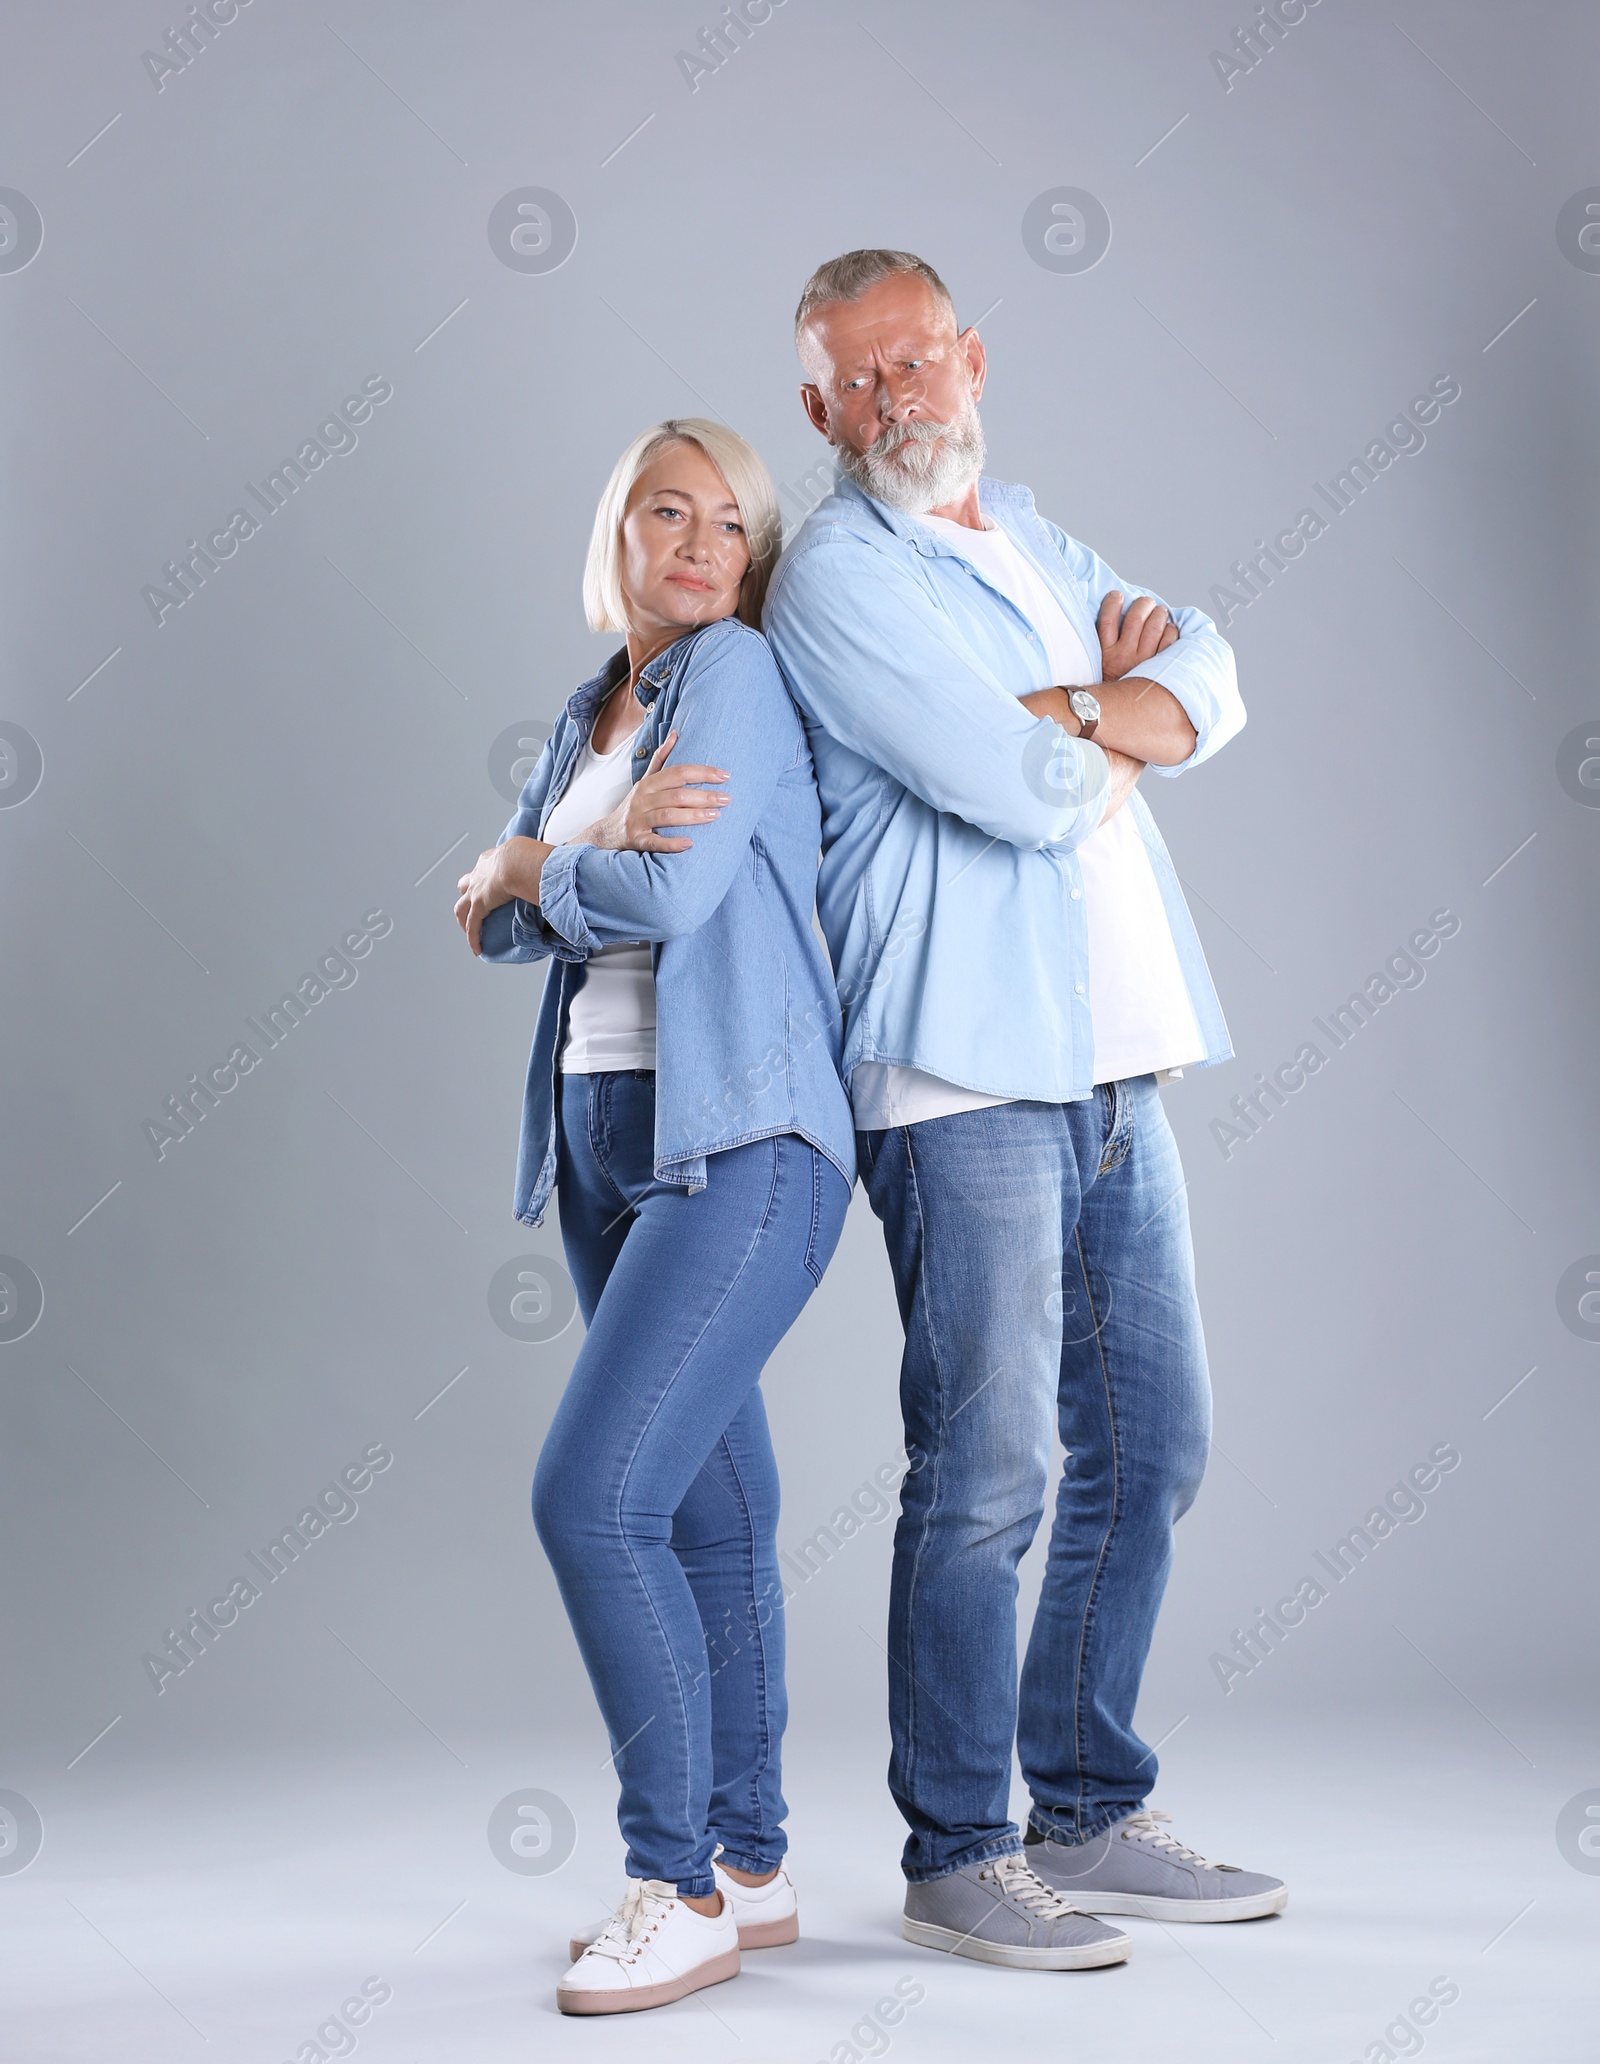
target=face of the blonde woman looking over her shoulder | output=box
[621,444,749,640]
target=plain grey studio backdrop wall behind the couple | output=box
[0,0,1600,2054]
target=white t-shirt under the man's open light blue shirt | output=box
[851,516,1206,1131]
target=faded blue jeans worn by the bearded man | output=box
[857,1075,1210,1880]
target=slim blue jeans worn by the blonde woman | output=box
[533,1073,851,1897]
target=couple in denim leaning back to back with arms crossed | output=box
[456,250,1286,2014]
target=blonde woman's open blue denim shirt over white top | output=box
[483,617,855,1226]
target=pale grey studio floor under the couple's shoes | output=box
[0,1707,1600,2064]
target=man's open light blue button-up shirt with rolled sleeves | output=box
[764,477,1245,1102]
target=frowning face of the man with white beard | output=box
[801,272,985,514]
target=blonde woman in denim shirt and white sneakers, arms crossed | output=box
[456,417,855,2014]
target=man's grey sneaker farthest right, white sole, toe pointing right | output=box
[1026,1810,1288,1922]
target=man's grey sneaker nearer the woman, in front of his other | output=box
[900,1856,1133,1971]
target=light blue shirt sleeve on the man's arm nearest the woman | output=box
[766,530,1111,850]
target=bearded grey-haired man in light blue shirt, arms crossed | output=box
[766,250,1286,1969]
